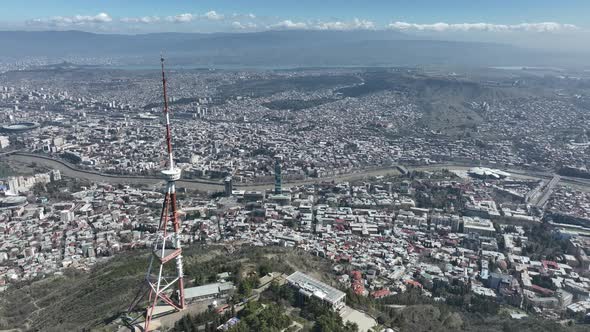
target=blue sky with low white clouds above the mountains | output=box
[0,0,590,46]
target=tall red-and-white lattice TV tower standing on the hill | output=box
[129,57,185,331]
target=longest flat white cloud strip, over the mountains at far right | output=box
[388,22,578,32]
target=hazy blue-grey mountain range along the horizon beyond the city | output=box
[0,31,586,67]
